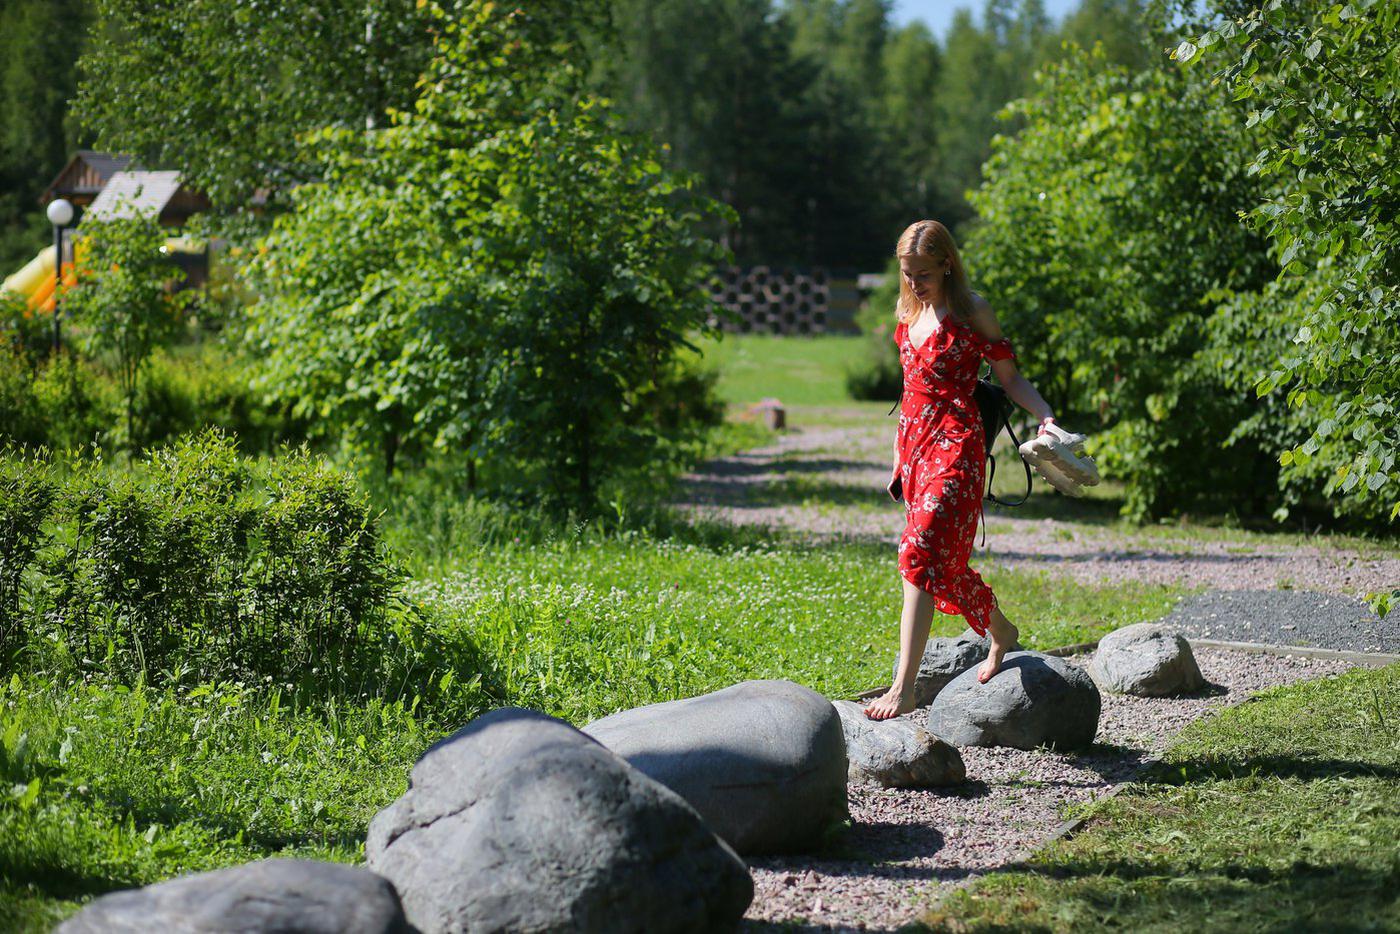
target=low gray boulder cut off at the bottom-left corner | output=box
[57,860,412,934]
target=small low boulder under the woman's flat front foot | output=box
[832,700,967,788]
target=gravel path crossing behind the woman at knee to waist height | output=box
[676,407,1400,594]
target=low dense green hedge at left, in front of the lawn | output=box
[17,431,403,688]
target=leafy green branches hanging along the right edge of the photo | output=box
[1173,0,1400,521]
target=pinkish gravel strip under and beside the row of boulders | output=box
[745,647,1350,931]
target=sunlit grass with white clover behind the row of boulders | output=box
[0,514,1177,930]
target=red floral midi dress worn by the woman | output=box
[895,315,1016,636]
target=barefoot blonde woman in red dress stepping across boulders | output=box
[865,220,1054,720]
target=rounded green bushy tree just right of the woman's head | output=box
[966,52,1287,520]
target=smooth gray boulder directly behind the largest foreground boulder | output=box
[584,681,847,854]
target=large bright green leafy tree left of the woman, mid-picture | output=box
[248,0,739,513]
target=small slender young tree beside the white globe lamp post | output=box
[62,211,190,447]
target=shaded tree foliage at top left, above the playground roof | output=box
[74,0,430,209]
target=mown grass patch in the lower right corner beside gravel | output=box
[923,665,1400,933]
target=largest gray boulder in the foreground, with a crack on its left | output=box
[365,709,753,934]
